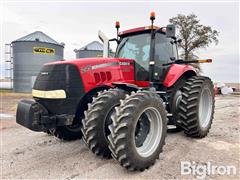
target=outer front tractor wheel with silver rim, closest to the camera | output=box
[108,91,167,171]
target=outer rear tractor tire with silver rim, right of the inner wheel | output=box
[179,76,215,138]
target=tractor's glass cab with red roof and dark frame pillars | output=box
[115,26,178,81]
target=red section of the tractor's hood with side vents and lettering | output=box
[46,58,134,92]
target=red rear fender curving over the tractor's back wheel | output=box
[163,64,197,87]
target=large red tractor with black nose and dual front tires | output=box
[16,13,214,171]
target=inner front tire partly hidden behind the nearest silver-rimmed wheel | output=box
[81,88,126,158]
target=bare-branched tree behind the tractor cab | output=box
[169,14,219,68]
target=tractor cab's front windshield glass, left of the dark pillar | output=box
[116,33,151,71]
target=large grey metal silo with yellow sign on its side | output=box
[12,31,64,92]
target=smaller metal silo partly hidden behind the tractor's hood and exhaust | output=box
[74,41,103,59]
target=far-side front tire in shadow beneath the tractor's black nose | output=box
[52,124,82,141]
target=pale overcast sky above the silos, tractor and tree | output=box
[1,1,239,82]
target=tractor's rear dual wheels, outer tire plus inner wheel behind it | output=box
[168,76,215,138]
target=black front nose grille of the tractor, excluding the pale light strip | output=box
[33,64,84,114]
